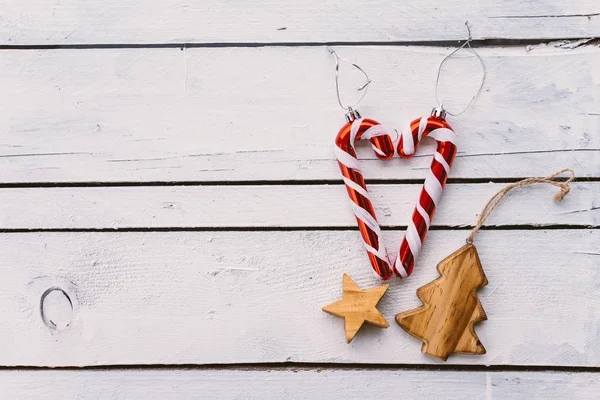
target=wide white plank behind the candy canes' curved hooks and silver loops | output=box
[0,45,600,182]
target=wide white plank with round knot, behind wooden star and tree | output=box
[0,230,600,366]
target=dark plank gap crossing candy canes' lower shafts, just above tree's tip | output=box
[0,224,600,233]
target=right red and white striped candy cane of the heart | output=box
[394,108,456,278]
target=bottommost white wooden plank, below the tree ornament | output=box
[0,368,600,400]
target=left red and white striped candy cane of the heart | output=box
[334,110,394,279]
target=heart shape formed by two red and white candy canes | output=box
[334,110,456,280]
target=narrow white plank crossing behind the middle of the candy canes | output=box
[0,182,600,229]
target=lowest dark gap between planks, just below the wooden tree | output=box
[0,362,600,373]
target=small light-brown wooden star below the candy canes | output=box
[323,274,390,343]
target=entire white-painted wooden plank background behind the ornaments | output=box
[0,0,600,400]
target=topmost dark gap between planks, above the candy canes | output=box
[0,36,597,50]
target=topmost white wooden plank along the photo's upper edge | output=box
[0,0,600,45]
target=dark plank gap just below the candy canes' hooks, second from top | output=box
[0,177,600,189]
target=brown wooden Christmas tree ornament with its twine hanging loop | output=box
[396,169,575,361]
